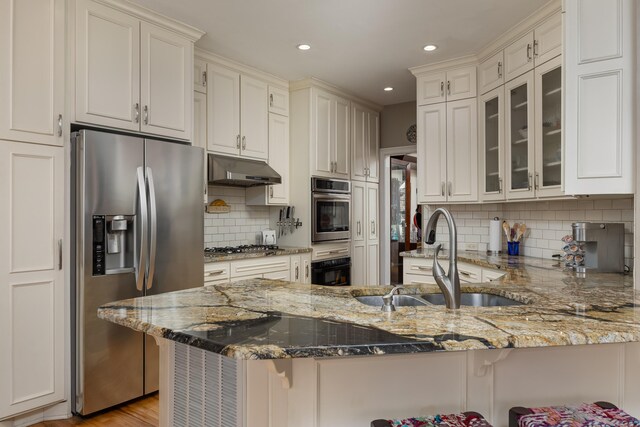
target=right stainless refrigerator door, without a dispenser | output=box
[144,139,204,394]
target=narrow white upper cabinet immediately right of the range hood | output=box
[246,113,291,205]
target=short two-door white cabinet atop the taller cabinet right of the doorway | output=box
[416,66,477,105]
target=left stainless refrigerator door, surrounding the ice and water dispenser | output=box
[74,131,144,415]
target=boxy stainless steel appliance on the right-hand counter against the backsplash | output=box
[571,222,624,273]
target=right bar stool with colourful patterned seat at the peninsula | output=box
[509,402,640,427]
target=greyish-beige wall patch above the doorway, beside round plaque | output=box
[380,101,416,148]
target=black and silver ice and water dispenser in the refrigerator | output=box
[93,215,135,276]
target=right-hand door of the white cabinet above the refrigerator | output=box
[140,22,193,139]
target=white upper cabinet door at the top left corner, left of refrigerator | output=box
[0,0,65,145]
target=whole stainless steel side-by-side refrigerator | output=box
[71,130,205,415]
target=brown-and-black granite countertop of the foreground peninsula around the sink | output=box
[98,253,640,359]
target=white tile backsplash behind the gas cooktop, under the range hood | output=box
[204,186,269,247]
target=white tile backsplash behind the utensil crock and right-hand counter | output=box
[425,198,633,268]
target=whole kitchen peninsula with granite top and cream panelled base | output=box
[99,253,640,427]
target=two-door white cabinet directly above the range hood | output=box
[207,63,269,160]
